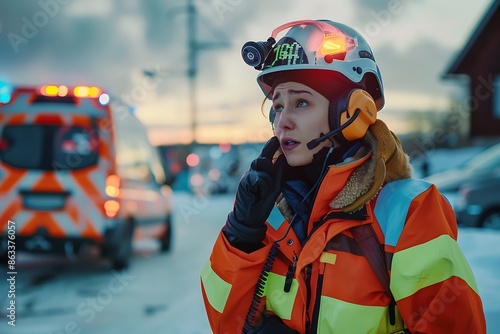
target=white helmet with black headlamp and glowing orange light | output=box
[241,20,384,110]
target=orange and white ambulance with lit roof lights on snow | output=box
[0,85,172,270]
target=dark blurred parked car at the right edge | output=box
[454,174,500,230]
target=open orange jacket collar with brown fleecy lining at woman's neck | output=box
[277,120,413,224]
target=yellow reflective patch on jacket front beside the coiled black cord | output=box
[265,273,299,320]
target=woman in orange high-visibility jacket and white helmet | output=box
[202,20,486,333]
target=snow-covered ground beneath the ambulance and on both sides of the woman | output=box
[0,193,500,334]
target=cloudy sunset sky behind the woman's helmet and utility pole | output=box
[0,0,492,144]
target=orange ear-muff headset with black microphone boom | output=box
[269,88,377,150]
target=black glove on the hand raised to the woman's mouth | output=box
[222,137,286,252]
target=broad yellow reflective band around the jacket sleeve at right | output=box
[391,235,479,300]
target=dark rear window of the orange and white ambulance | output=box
[0,125,99,170]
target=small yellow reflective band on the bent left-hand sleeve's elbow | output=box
[201,261,231,313]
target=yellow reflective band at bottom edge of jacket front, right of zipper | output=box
[318,296,404,334]
